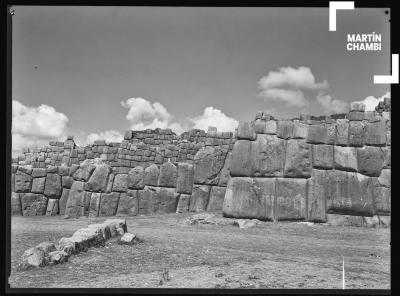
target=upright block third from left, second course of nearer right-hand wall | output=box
[283,140,312,178]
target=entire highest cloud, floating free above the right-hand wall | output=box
[258,66,329,108]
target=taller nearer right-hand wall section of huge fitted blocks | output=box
[223,100,391,222]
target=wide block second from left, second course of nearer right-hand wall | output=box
[252,135,286,177]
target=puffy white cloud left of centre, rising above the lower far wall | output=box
[121,98,183,133]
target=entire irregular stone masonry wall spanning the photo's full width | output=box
[12,101,391,222]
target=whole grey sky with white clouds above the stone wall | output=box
[12,6,390,154]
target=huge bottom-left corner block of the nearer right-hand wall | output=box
[223,177,275,220]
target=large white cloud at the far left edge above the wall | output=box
[11,100,68,155]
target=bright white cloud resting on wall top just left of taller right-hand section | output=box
[190,106,238,132]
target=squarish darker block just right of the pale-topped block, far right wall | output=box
[357,146,385,177]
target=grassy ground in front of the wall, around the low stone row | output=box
[9,214,390,289]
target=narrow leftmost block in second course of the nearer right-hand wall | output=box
[230,137,252,176]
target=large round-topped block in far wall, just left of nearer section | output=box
[194,146,227,185]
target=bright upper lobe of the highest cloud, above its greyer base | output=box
[259,66,329,90]
